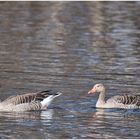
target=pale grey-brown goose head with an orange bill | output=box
[88,84,105,94]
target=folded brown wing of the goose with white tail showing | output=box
[3,90,56,105]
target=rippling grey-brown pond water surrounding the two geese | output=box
[0,2,140,139]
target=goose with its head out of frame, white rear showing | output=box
[0,90,62,112]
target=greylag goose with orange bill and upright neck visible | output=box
[88,84,140,109]
